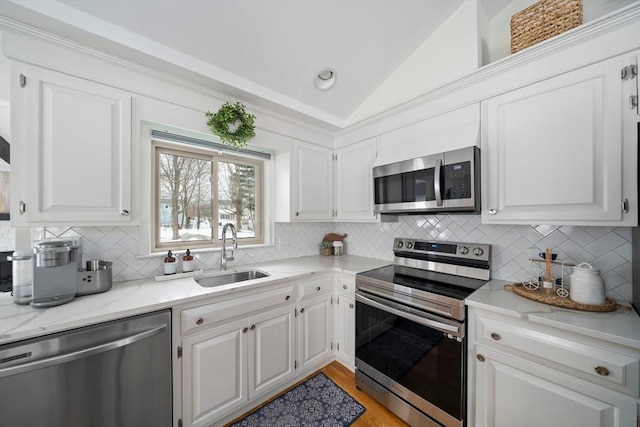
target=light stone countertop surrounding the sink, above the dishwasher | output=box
[0,255,391,345]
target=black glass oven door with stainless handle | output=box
[356,290,466,426]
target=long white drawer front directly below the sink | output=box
[180,285,295,335]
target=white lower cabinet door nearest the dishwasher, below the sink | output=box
[182,321,248,426]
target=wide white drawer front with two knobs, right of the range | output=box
[476,316,640,397]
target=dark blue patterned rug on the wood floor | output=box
[231,373,366,427]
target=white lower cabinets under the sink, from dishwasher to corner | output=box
[172,274,335,427]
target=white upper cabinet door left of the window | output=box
[11,63,131,225]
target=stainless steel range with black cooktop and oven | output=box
[356,238,491,427]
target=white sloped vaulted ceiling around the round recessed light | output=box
[0,0,509,128]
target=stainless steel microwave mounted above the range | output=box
[373,147,480,214]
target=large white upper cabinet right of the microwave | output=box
[482,51,638,226]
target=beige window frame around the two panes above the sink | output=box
[150,137,266,253]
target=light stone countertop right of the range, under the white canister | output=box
[465,280,640,349]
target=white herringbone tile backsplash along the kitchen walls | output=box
[6,215,632,300]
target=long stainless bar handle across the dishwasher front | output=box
[0,325,167,378]
